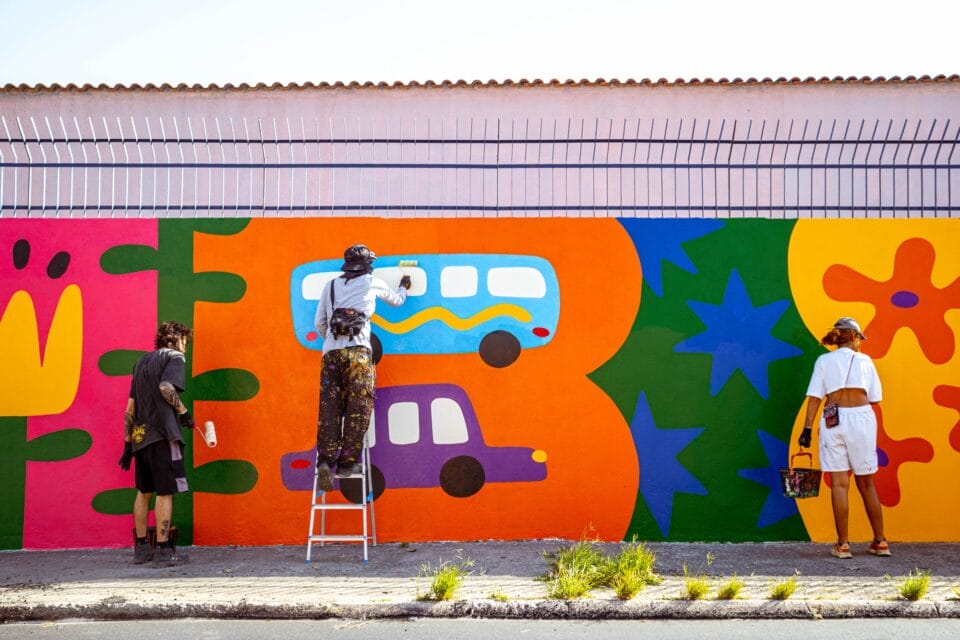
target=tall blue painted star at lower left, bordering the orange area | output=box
[630,391,707,537]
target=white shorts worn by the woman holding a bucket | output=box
[819,405,877,476]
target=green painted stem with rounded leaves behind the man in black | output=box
[93,219,260,545]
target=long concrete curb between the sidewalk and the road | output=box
[0,599,960,623]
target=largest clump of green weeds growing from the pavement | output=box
[543,538,660,600]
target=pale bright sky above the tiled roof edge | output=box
[0,0,960,85]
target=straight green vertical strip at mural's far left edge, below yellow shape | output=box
[0,416,27,549]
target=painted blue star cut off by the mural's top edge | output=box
[620,219,723,296]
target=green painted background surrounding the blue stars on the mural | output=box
[589,220,822,541]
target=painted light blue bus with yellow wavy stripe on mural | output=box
[290,253,560,367]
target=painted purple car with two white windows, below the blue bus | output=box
[280,384,547,502]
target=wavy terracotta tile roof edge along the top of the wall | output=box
[0,74,960,93]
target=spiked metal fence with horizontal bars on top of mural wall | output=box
[0,115,960,218]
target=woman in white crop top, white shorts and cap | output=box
[798,317,890,558]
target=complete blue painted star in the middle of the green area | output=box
[674,269,803,398]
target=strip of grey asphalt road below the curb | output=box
[0,618,960,640]
